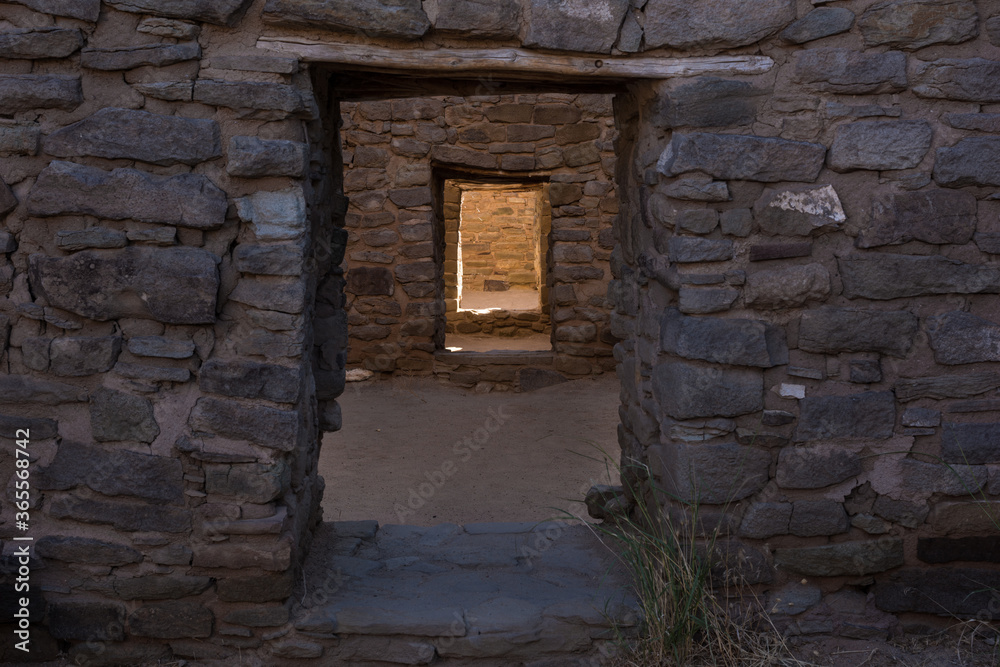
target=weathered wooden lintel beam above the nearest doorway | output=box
[257,36,774,80]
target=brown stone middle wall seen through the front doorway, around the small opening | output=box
[341,94,618,375]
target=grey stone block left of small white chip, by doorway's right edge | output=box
[653,361,764,419]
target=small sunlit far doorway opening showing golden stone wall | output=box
[444,180,552,352]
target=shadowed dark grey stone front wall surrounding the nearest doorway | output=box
[0,0,1000,664]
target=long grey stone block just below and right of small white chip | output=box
[795,391,896,442]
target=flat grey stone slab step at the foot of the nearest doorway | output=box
[294,522,639,666]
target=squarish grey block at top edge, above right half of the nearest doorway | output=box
[524,0,629,53]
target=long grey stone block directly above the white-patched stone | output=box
[657,132,826,183]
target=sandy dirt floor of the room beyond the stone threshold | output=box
[319,374,619,526]
